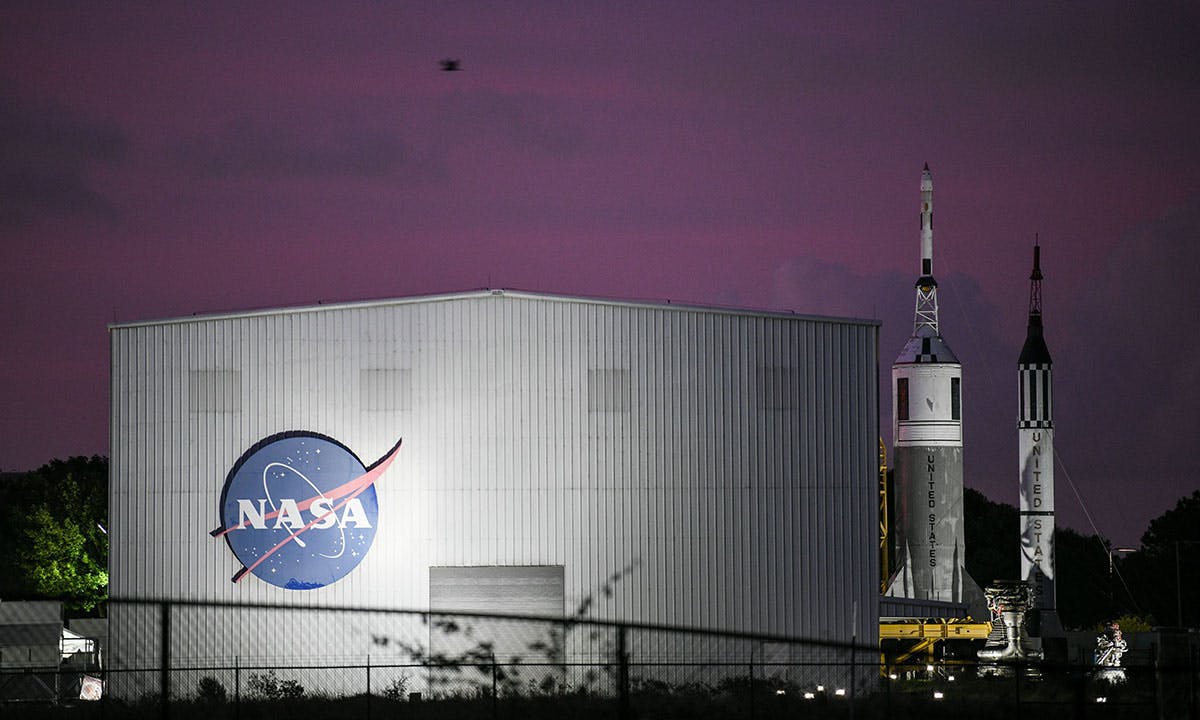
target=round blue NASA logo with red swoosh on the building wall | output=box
[211,431,400,590]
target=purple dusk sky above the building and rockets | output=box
[0,1,1200,545]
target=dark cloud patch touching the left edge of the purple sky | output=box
[0,83,127,227]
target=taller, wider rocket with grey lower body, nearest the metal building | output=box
[886,164,983,607]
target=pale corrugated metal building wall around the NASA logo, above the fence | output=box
[110,292,878,661]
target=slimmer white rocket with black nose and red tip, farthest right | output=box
[1016,241,1061,636]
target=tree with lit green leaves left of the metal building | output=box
[5,456,108,611]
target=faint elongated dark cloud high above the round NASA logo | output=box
[179,116,413,180]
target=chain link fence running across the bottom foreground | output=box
[0,601,1198,720]
